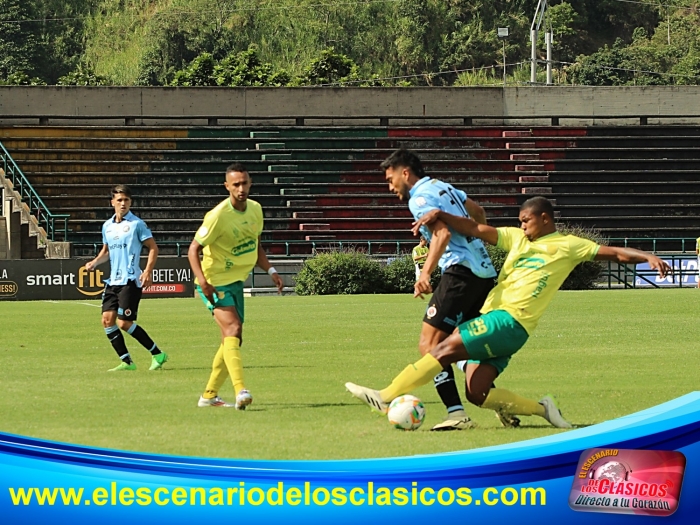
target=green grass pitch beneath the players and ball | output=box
[0,289,700,459]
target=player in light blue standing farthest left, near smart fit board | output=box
[85,184,168,372]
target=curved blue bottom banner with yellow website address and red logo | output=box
[0,392,700,525]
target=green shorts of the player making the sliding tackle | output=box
[459,310,528,374]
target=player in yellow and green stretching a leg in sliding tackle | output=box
[345,197,671,428]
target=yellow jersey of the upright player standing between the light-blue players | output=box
[194,199,263,286]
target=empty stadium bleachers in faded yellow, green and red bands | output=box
[0,126,700,255]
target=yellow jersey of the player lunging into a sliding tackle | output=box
[481,228,600,334]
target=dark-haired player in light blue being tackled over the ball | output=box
[370,149,519,430]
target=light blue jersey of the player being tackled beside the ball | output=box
[408,177,496,278]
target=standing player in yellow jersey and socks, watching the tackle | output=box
[187,163,283,410]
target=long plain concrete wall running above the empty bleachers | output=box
[0,86,700,125]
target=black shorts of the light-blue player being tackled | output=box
[423,264,494,334]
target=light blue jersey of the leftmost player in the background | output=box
[102,212,153,288]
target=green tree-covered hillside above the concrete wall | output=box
[0,0,700,86]
